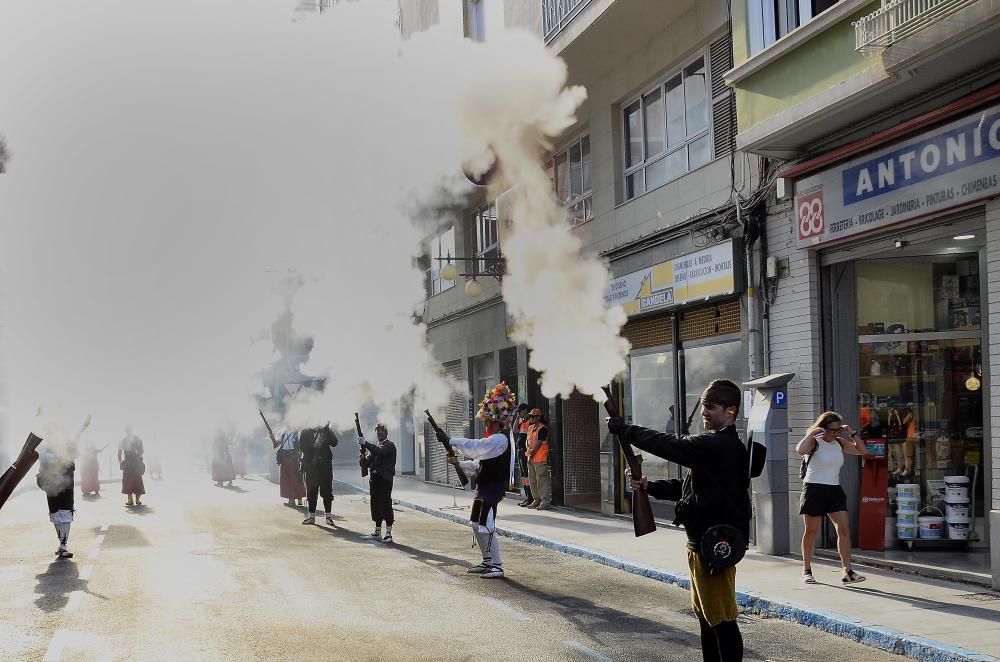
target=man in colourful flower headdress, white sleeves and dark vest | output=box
[426,382,517,579]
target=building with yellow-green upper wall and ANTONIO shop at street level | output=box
[726,0,1000,587]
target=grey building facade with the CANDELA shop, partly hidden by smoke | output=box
[400,0,768,517]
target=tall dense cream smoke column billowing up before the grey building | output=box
[460,39,629,401]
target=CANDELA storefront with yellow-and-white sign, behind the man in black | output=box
[601,240,747,519]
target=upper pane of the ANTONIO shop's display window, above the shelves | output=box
[857,255,982,335]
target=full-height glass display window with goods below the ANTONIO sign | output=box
[855,254,985,532]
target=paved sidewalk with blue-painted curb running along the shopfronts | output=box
[338,478,1000,661]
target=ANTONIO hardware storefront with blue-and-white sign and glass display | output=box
[792,100,1000,577]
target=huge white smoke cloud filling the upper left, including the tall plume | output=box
[0,0,624,472]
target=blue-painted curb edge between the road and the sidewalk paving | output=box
[338,481,1000,662]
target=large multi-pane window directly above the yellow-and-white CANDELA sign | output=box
[622,57,712,200]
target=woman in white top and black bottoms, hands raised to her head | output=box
[795,411,866,584]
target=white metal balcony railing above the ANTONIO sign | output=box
[853,0,979,53]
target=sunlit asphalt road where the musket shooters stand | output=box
[0,468,900,662]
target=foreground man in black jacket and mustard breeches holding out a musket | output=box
[608,379,751,662]
